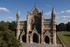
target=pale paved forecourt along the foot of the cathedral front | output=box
[22,43,57,47]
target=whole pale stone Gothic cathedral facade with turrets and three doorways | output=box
[16,5,56,44]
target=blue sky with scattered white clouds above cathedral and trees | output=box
[0,0,70,24]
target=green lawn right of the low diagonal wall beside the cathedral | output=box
[57,31,70,47]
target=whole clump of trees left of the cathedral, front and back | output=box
[0,21,21,47]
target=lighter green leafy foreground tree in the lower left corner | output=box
[0,30,21,47]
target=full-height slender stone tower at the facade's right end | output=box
[51,7,56,44]
